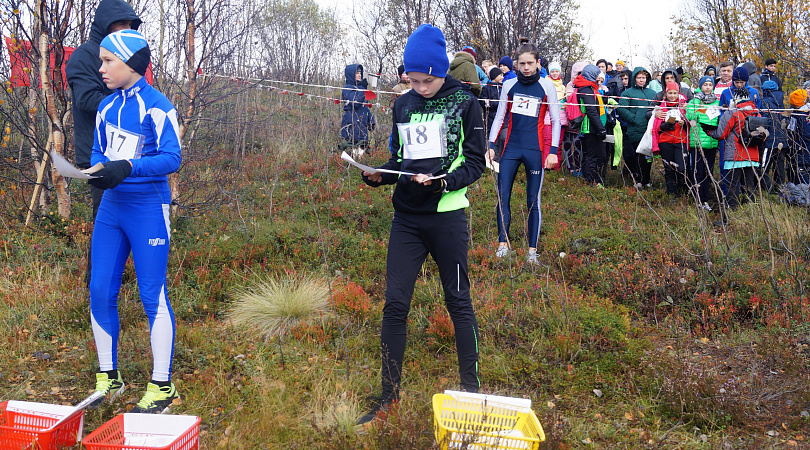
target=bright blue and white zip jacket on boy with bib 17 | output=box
[90,78,181,203]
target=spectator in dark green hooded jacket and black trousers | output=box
[616,67,655,188]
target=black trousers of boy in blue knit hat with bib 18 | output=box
[380,209,480,402]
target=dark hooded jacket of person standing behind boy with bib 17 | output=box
[65,0,141,169]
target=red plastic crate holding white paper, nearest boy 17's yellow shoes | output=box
[82,413,200,450]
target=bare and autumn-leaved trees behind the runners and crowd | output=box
[0,0,810,223]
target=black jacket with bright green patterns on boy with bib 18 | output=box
[363,75,486,214]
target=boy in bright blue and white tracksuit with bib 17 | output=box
[88,30,181,413]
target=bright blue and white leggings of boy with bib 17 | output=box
[90,199,175,381]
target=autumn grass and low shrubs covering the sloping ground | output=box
[0,103,810,449]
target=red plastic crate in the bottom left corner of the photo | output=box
[0,400,84,450]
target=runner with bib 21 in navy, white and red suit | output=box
[489,43,560,264]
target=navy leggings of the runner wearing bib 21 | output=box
[495,147,543,248]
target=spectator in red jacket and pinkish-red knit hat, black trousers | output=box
[652,81,689,197]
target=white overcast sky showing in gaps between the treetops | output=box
[316,0,683,67]
